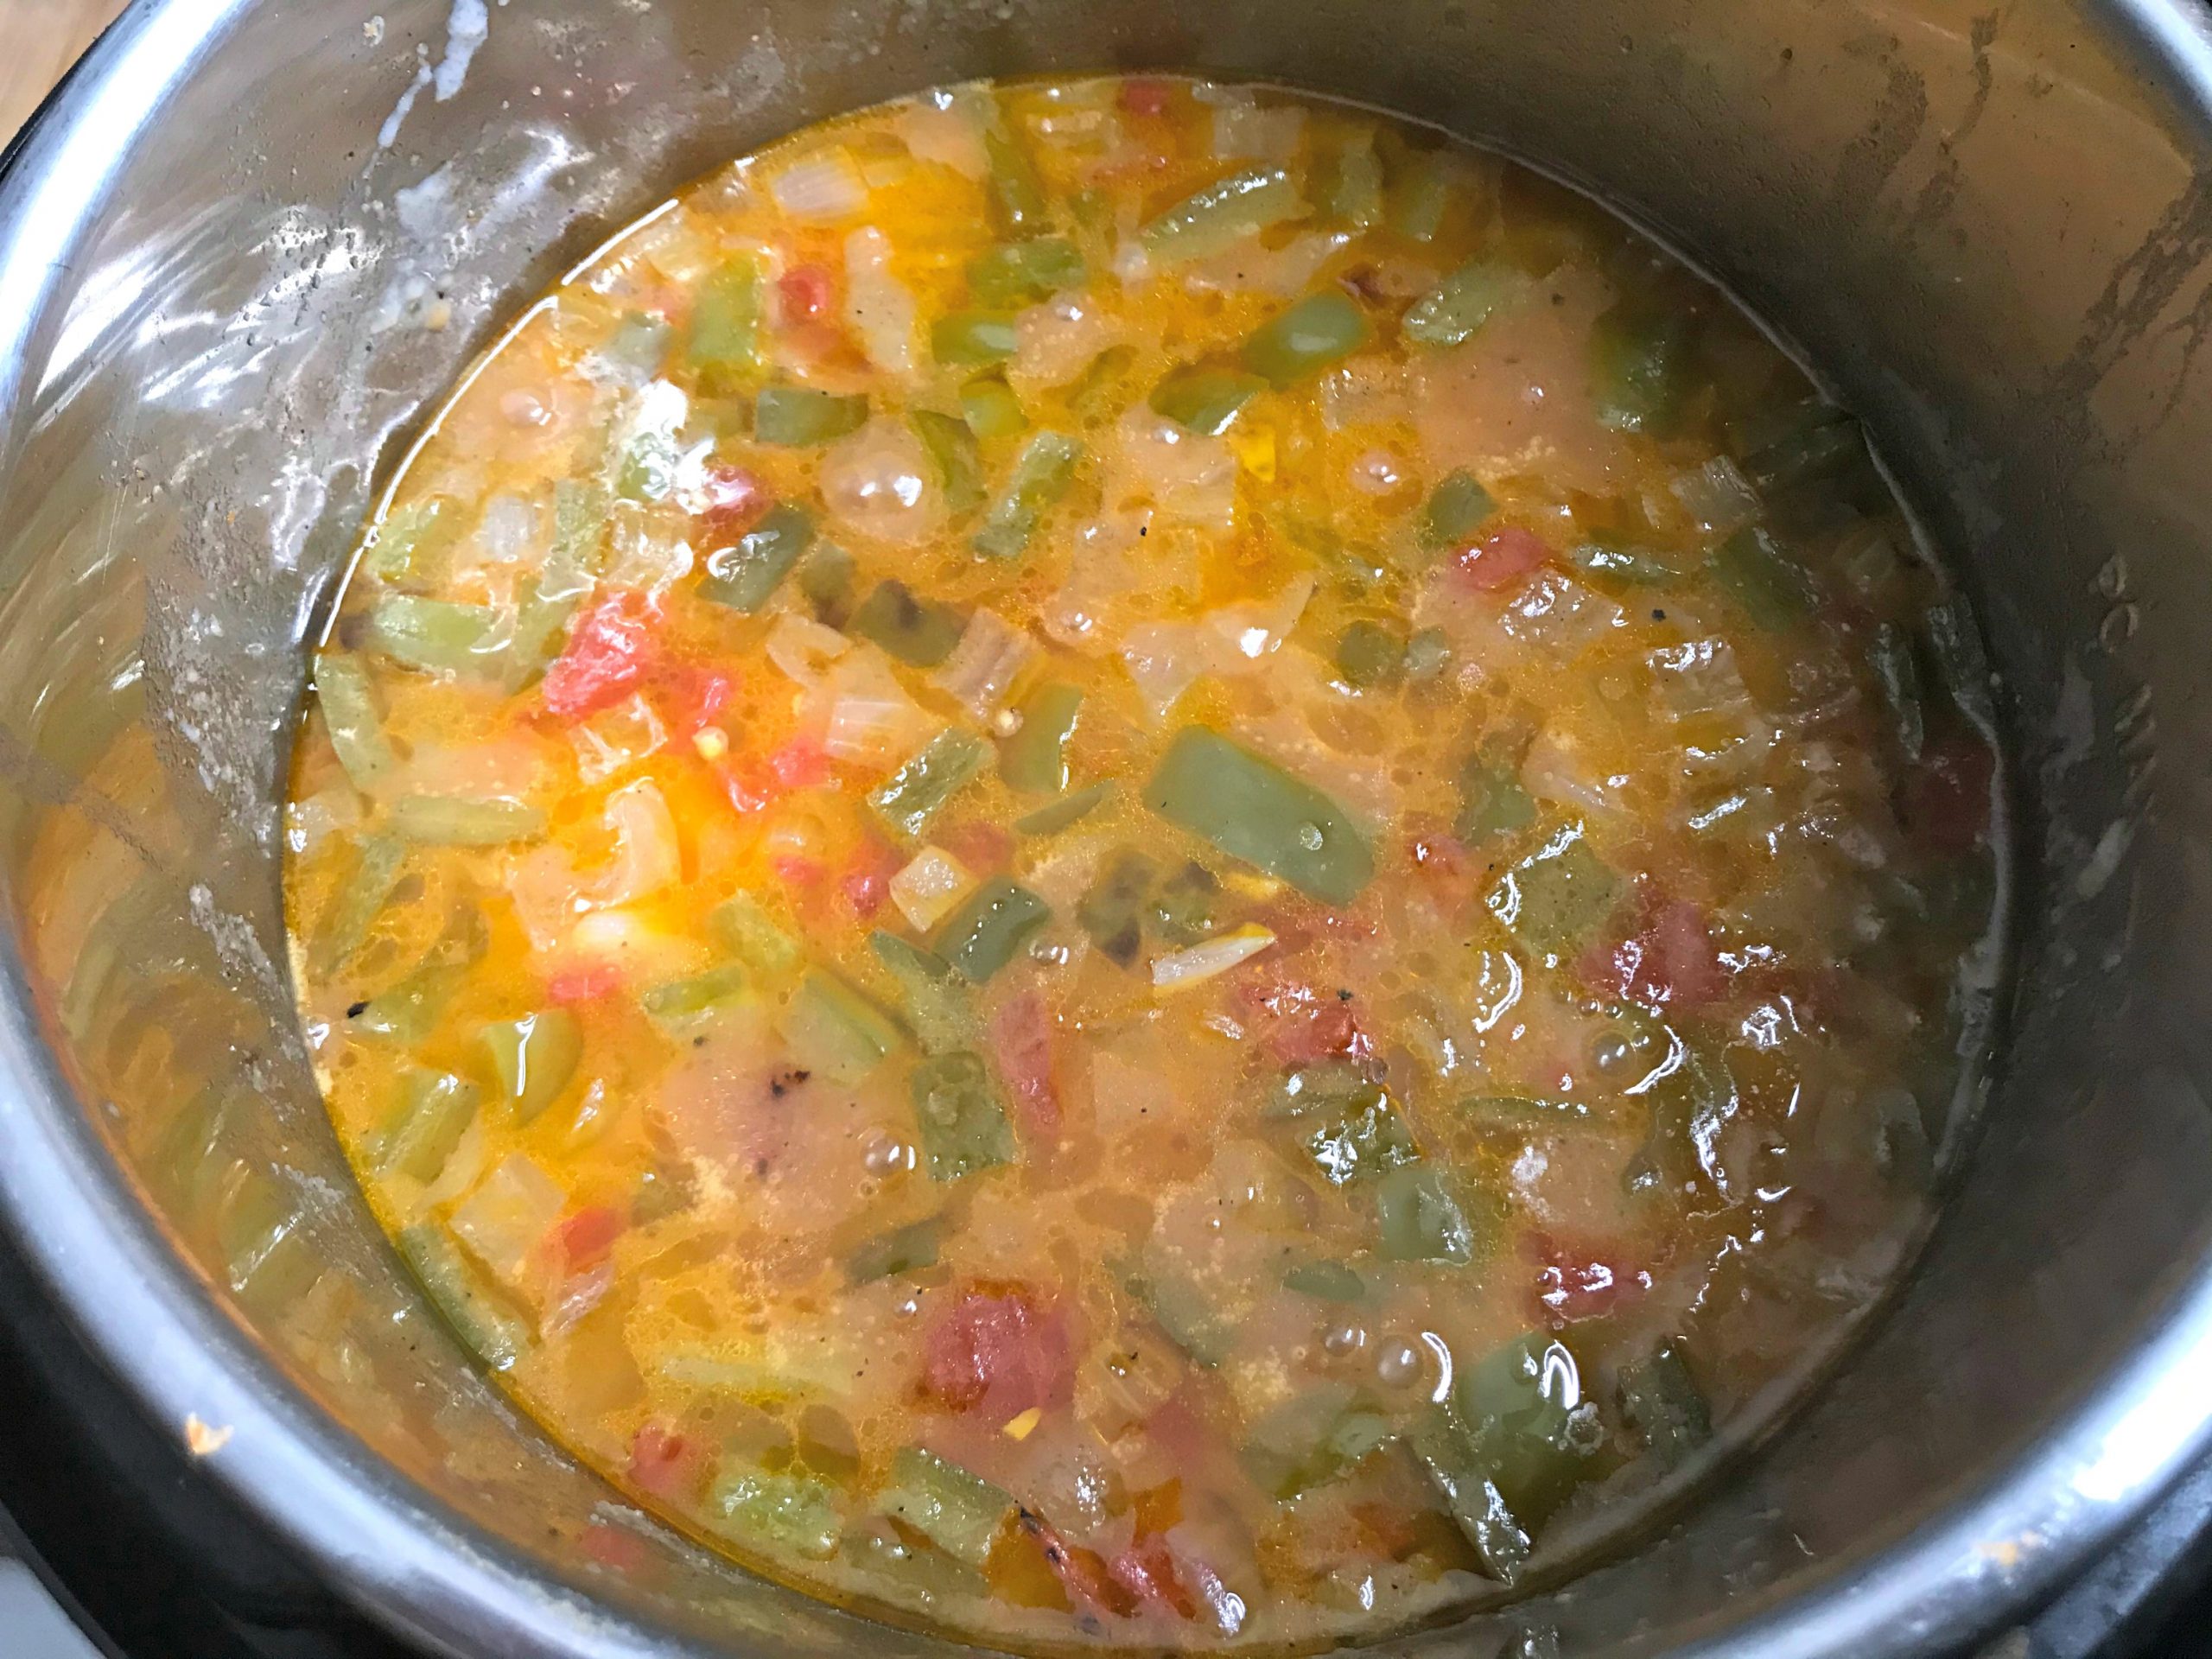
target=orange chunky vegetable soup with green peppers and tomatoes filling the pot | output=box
[285,78,1998,1648]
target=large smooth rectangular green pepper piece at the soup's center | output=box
[1144,726,1376,905]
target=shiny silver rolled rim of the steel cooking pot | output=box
[0,0,2212,1659]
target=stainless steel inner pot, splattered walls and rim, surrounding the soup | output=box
[0,0,2212,1659]
